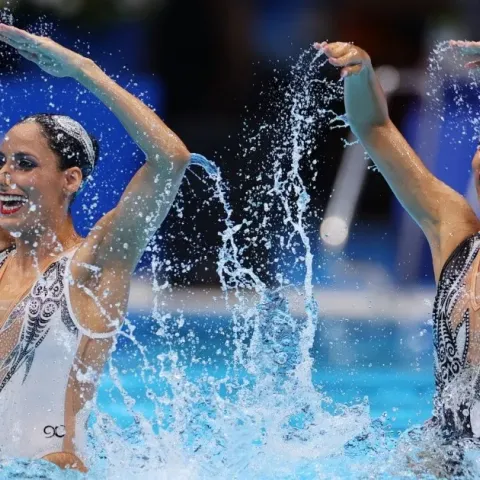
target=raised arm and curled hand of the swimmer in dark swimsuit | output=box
[315,42,479,278]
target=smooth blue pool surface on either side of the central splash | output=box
[99,315,434,433]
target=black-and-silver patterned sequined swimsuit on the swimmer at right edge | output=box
[433,233,480,438]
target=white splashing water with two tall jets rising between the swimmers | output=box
[54,47,376,478]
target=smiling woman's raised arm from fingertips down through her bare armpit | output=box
[0,24,190,333]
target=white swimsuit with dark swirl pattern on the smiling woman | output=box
[0,249,116,460]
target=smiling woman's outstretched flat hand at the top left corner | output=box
[0,23,87,77]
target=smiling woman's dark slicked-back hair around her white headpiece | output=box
[19,113,99,202]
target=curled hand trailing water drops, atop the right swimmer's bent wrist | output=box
[313,42,371,78]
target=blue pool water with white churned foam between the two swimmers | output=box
[74,314,434,479]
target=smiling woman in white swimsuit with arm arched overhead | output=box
[0,24,190,471]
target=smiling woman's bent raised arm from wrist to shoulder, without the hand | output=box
[74,51,190,273]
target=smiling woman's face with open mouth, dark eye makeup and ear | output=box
[0,122,81,232]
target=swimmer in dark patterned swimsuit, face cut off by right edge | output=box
[315,41,480,474]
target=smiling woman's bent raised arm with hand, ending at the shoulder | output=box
[0,24,190,260]
